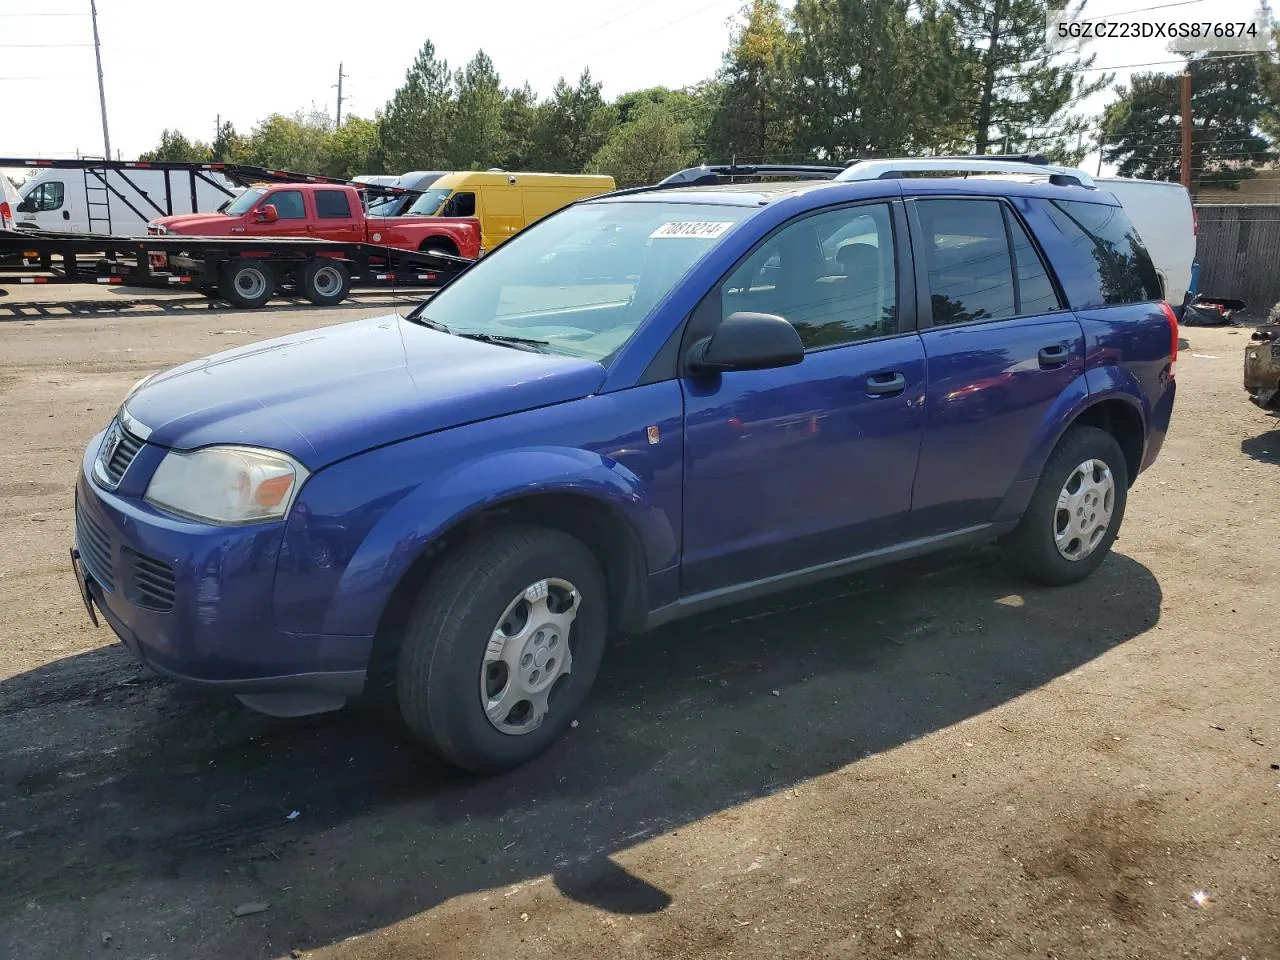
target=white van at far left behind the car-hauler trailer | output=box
[17,169,243,237]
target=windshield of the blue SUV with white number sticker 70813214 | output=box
[410,201,754,362]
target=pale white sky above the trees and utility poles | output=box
[0,0,1257,180]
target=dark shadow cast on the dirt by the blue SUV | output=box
[0,549,1161,957]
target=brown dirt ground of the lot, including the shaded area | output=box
[0,295,1280,960]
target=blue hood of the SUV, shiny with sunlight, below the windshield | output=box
[124,314,605,471]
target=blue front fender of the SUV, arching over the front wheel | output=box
[273,381,684,635]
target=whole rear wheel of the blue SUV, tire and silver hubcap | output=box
[1001,426,1129,586]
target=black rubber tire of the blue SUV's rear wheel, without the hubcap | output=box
[1000,425,1129,586]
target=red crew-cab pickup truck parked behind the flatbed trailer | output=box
[147,183,480,260]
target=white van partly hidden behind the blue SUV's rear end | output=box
[1093,177,1197,308]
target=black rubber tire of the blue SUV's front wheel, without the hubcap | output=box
[396,527,609,773]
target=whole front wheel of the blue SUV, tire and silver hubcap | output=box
[396,527,608,773]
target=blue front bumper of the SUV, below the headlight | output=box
[76,436,372,696]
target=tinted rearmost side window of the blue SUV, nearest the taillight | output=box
[1044,200,1162,303]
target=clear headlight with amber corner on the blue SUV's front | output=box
[146,447,307,524]
